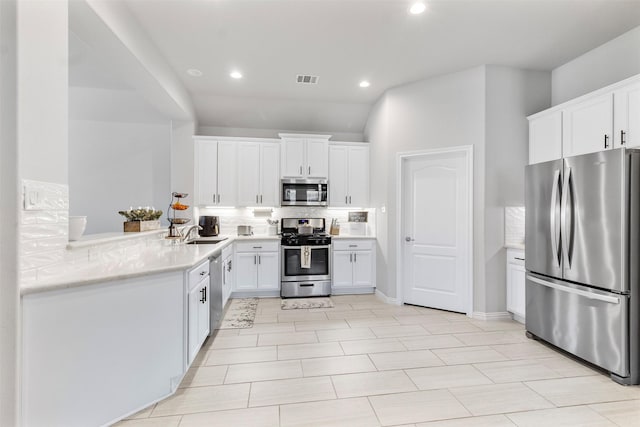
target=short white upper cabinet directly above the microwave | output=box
[280,133,331,178]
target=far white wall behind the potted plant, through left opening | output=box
[69,119,171,234]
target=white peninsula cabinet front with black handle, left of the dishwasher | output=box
[187,261,211,365]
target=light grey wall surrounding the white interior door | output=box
[365,67,484,304]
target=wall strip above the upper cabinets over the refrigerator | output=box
[542,27,640,105]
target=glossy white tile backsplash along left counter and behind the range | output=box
[18,181,375,284]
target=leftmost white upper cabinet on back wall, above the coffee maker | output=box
[194,138,237,206]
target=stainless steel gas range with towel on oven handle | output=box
[280,218,331,298]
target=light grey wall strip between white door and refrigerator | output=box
[484,65,551,313]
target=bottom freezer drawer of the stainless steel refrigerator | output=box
[525,273,629,377]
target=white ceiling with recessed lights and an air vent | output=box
[100,0,640,132]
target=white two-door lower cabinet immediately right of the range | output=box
[331,239,375,294]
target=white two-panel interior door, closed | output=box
[401,151,471,312]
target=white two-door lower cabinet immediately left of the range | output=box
[234,240,280,291]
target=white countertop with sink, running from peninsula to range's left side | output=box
[20,235,280,295]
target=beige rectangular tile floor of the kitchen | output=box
[117,295,640,427]
